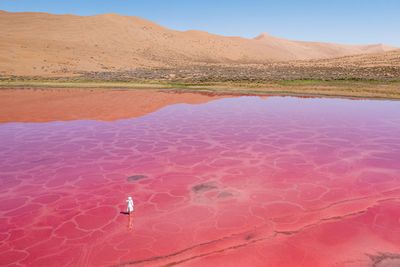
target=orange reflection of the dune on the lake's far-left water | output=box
[0,88,226,122]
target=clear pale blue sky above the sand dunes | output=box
[0,0,400,47]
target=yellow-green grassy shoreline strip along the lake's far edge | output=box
[0,80,400,100]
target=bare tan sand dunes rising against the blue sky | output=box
[0,11,392,76]
